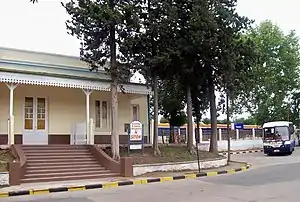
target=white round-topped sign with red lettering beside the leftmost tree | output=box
[128,121,144,153]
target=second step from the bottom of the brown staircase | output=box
[24,170,111,179]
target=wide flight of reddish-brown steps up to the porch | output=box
[21,145,120,183]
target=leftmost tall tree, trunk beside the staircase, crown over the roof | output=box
[62,0,140,159]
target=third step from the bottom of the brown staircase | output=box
[26,165,106,174]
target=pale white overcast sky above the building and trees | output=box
[0,0,300,119]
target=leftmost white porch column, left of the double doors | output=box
[6,83,18,145]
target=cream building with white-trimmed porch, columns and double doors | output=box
[0,48,151,145]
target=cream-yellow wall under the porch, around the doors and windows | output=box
[0,83,148,135]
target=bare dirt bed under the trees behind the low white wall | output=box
[106,146,221,164]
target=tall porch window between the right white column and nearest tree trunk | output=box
[95,100,108,128]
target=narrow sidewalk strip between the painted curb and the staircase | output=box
[0,163,245,195]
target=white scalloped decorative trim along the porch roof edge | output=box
[0,72,152,94]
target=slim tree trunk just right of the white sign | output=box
[153,74,160,155]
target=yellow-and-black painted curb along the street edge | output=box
[0,163,251,198]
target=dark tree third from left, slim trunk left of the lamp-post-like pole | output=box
[148,0,209,153]
